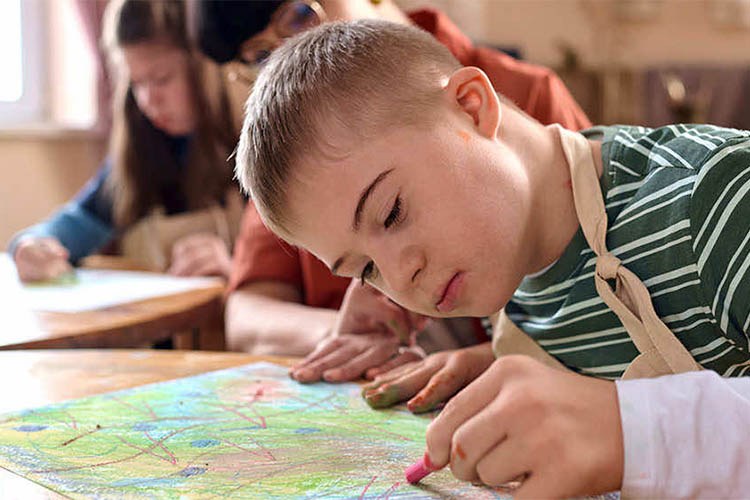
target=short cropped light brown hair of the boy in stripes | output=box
[235,20,461,235]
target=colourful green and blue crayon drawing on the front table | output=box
[0,363,505,499]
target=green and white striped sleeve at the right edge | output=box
[690,137,750,346]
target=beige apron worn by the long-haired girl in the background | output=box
[120,187,244,272]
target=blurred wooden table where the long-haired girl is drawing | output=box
[0,255,224,350]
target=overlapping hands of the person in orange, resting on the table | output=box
[290,280,426,382]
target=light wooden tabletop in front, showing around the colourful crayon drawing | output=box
[0,349,295,499]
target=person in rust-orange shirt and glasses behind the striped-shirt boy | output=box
[195,0,591,376]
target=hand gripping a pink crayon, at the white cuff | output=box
[427,356,624,498]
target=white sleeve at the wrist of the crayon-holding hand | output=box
[617,371,750,498]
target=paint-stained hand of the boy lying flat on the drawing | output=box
[362,342,495,413]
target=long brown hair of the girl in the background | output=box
[102,0,236,228]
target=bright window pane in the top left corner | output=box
[0,0,46,125]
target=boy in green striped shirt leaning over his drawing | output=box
[237,21,750,497]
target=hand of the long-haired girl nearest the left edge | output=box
[13,237,73,282]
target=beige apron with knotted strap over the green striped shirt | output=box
[492,125,701,379]
